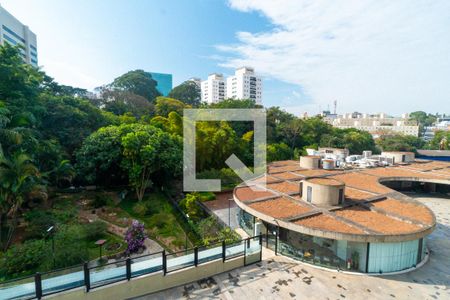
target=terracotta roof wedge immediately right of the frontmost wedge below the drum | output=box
[334,206,421,234]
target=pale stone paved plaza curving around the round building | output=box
[134,193,450,300]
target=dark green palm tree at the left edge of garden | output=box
[0,149,44,249]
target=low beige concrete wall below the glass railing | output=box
[49,252,260,300]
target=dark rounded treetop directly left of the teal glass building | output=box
[107,70,160,102]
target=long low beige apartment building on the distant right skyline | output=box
[324,112,419,138]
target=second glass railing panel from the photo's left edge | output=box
[41,266,84,296]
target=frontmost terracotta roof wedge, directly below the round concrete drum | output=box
[294,214,364,234]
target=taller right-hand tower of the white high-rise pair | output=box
[226,67,262,104]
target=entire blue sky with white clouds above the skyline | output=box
[0,0,450,115]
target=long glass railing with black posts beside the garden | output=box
[0,236,262,300]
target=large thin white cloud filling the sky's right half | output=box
[218,0,450,114]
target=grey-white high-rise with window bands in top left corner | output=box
[0,5,38,67]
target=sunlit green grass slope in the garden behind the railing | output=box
[119,192,193,251]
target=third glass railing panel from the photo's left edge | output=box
[89,261,127,288]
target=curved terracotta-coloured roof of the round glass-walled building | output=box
[234,161,450,242]
